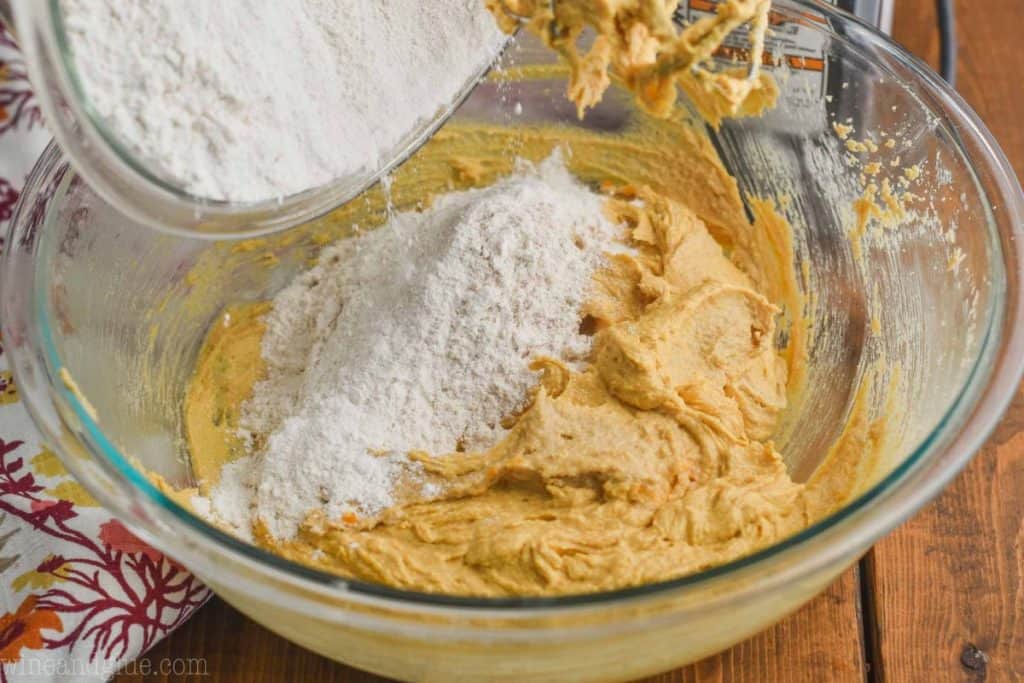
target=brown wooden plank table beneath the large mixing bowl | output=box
[121,0,1024,683]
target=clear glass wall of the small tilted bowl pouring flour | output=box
[11,0,498,238]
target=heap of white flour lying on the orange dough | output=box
[195,156,620,538]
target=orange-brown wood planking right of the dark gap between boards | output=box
[863,0,1024,683]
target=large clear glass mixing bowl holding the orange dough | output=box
[0,0,1024,681]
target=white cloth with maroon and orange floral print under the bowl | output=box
[0,26,208,683]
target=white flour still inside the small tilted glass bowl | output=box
[60,0,503,202]
